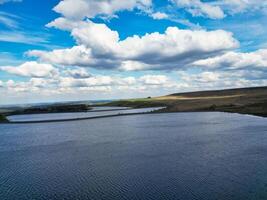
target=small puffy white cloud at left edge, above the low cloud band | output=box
[0,61,58,77]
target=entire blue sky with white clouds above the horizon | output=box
[0,0,267,105]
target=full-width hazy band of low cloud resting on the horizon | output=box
[0,70,267,103]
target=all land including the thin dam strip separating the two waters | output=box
[0,86,267,124]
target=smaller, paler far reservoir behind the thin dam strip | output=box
[8,107,163,122]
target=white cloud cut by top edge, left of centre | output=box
[54,0,152,19]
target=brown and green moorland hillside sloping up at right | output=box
[106,87,267,117]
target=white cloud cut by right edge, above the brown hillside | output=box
[193,49,267,69]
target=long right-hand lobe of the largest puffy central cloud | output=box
[118,27,239,60]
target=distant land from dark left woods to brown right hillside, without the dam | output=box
[0,87,267,122]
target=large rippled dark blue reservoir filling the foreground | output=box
[0,113,267,200]
